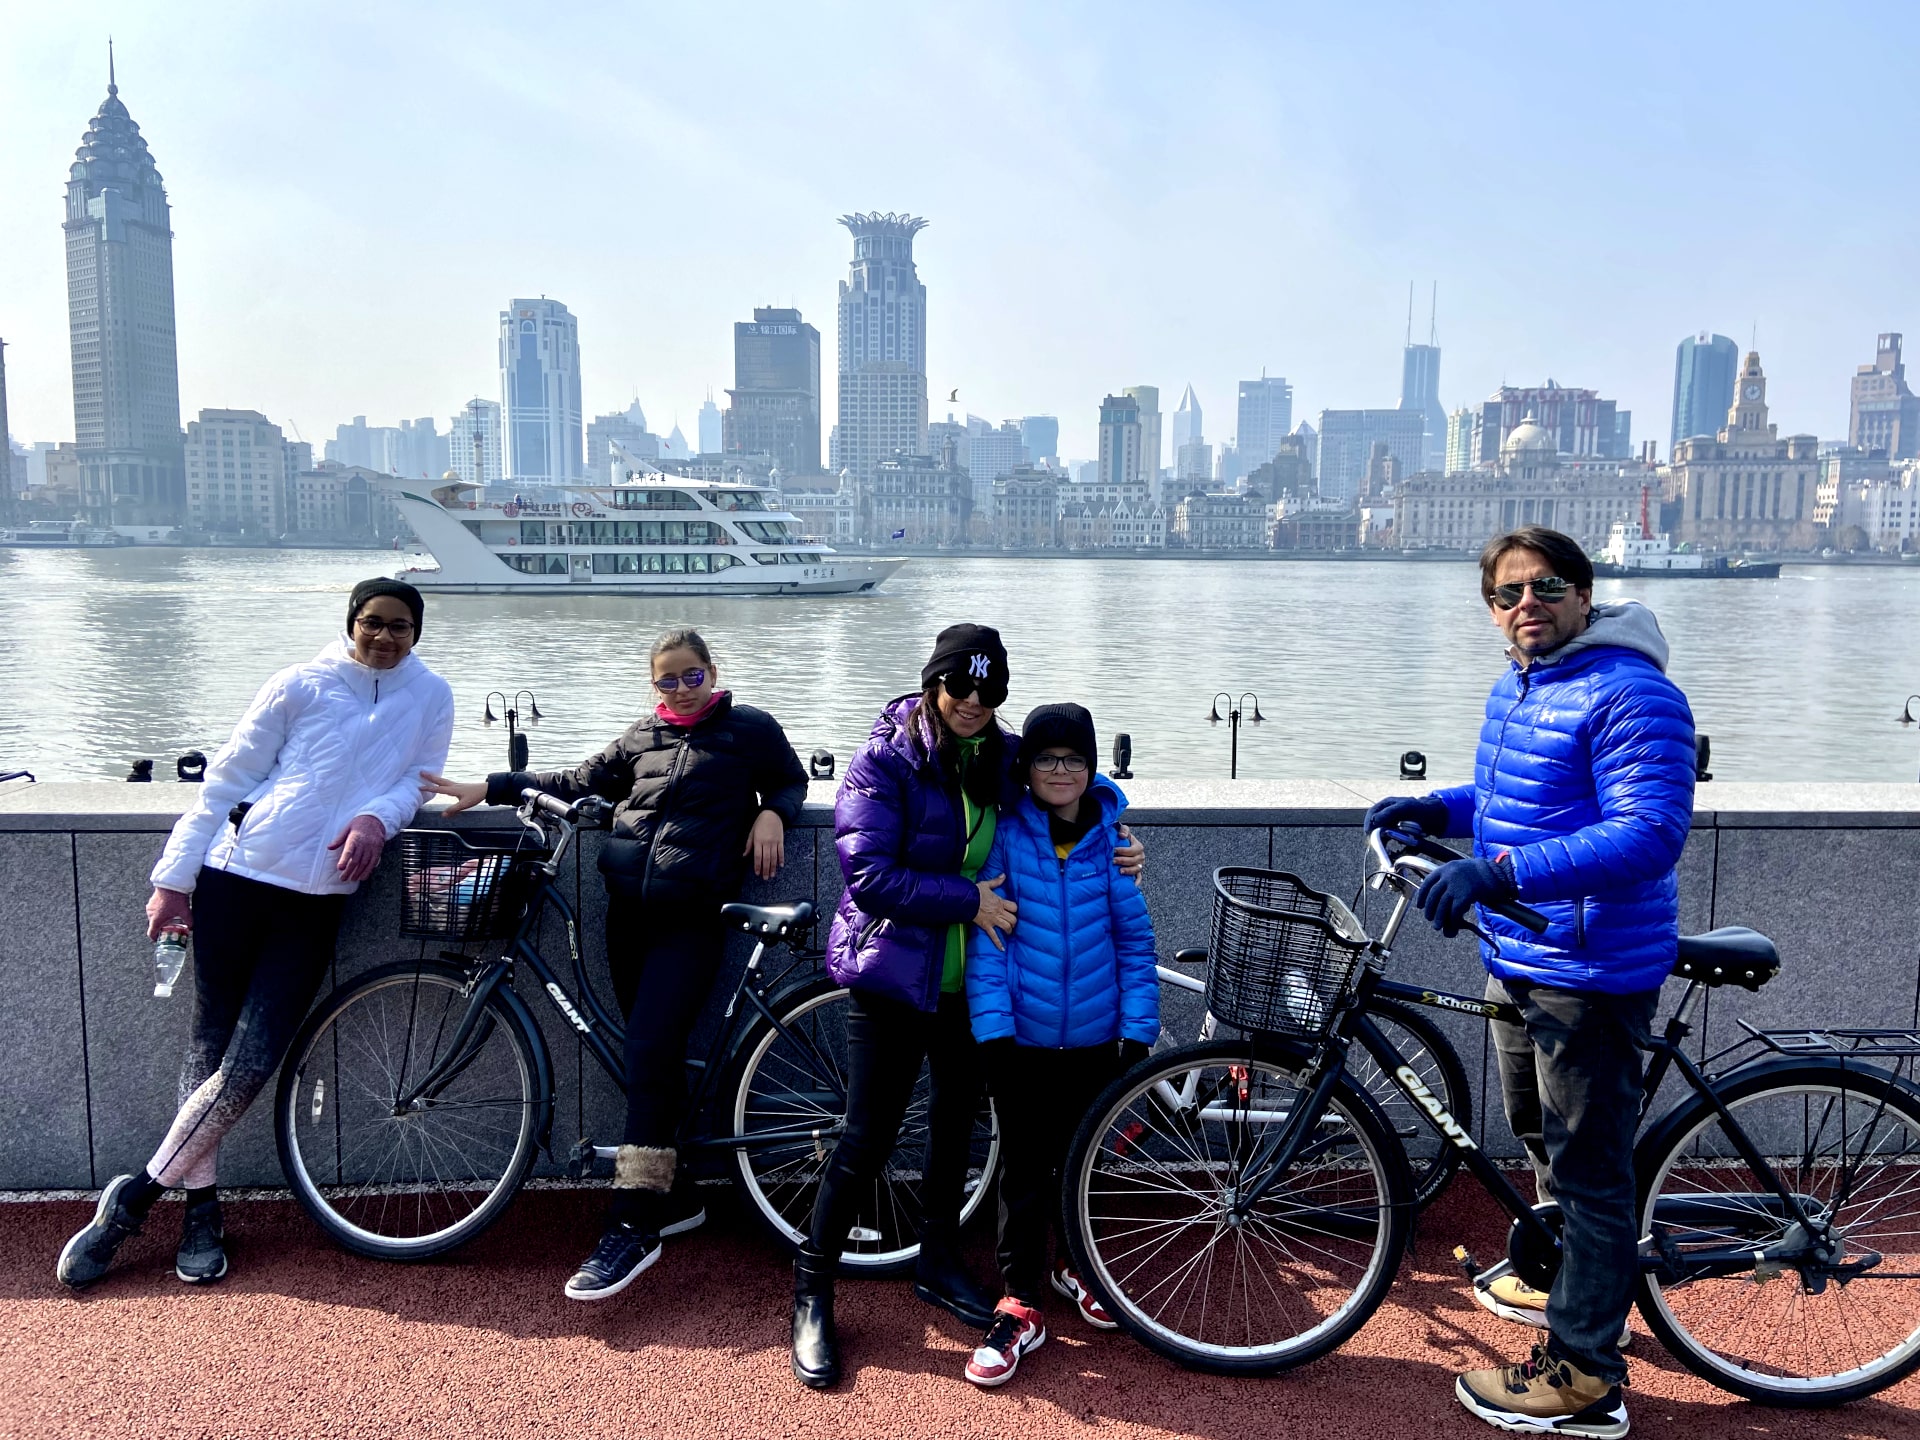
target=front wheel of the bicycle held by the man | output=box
[1068,1041,1411,1375]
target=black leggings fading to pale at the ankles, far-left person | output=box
[146,866,346,1188]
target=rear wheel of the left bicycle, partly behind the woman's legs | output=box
[732,975,1000,1273]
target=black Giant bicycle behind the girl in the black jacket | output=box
[275,789,998,1273]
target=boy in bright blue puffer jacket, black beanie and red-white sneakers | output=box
[966,705,1160,1386]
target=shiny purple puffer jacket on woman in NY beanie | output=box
[828,695,1014,1010]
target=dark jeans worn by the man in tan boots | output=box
[1486,977,1661,1384]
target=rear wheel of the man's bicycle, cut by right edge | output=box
[1634,1060,1920,1407]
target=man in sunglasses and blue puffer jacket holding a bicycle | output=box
[1367,526,1693,1436]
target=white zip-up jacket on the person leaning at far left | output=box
[152,636,453,895]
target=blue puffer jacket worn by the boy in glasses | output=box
[966,776,1160,1050]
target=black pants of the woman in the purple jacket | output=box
[808,991,981,1256]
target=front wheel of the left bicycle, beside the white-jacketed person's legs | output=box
[275,960,551,1260]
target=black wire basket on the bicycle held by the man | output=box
[1206,866,1367,1039]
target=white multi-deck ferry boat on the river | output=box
[382,472,906,595]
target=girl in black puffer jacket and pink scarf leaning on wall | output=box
[432,630,806,1300]
